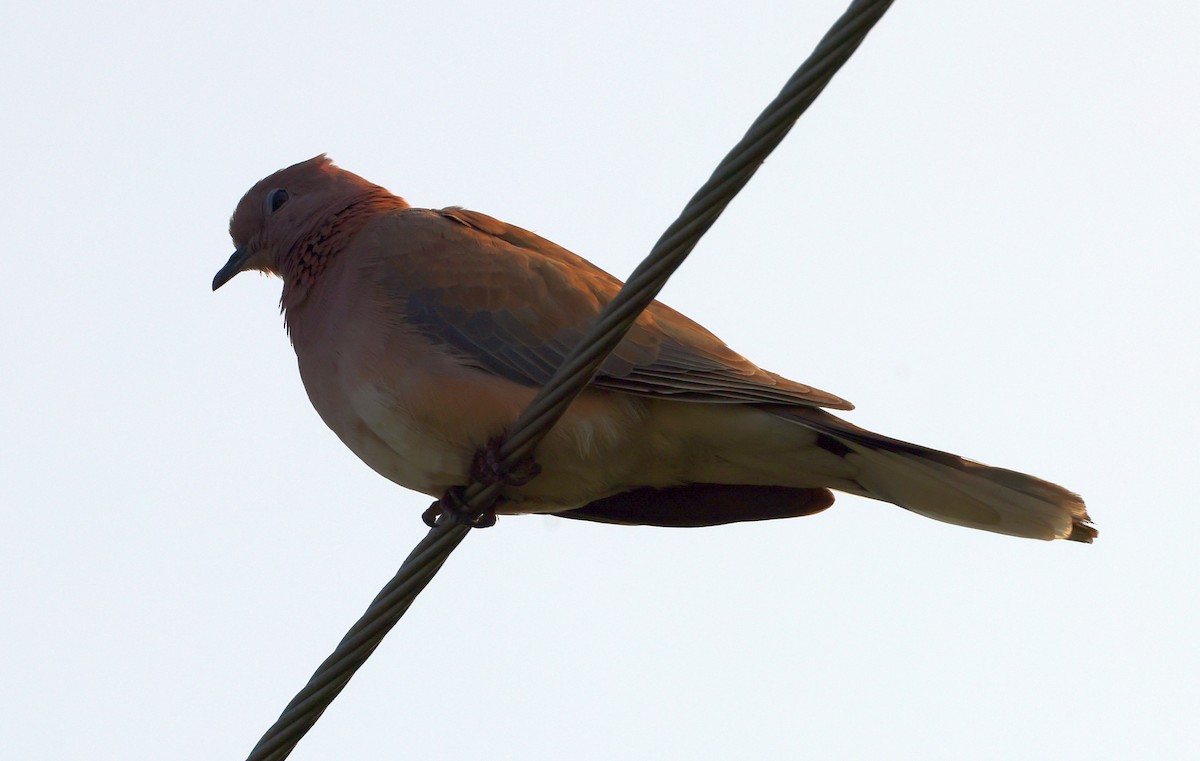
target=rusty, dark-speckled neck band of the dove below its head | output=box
[280,188,408,310]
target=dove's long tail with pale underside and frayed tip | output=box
[776,407,1097,543]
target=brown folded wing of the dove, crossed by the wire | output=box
[364,208,852,409]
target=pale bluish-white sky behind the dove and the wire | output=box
[0,0,1200,761]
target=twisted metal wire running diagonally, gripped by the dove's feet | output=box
[247,0,892,761]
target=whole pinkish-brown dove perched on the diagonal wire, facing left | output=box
[212,154,1097,543]
